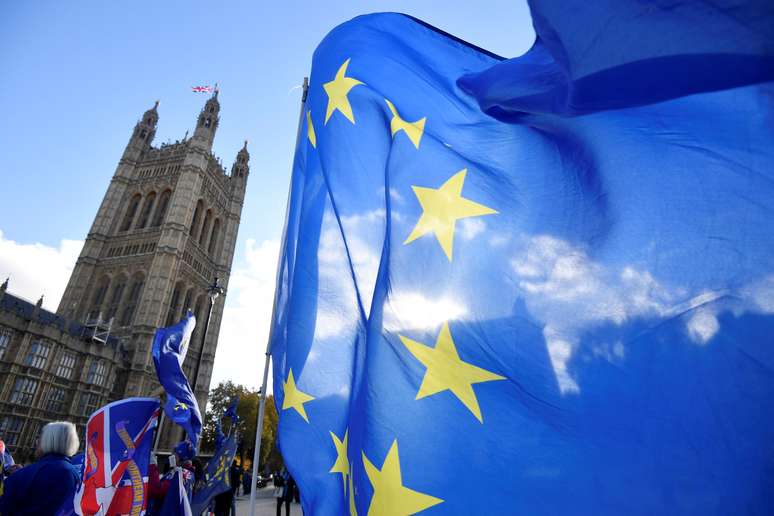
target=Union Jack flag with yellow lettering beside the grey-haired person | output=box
[73,398,161,516]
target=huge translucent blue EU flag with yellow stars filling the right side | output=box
[271,2,774,515]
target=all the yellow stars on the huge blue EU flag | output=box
[282,59,505,516]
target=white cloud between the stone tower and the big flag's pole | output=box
[210,239,280,392]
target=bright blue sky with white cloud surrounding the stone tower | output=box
[0,0,534,383]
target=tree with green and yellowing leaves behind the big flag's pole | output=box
[201,381,282,470]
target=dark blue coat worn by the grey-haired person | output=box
[0,453,80,516]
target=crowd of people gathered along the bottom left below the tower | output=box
[0,421,299,516]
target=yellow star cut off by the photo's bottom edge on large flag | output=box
[363,439,443,516]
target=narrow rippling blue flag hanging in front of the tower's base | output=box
[152,312,202,450]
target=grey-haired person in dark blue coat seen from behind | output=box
[0,421,80,516]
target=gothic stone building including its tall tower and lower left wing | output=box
[0,92,249,456]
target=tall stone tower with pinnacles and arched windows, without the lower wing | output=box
[57,91,250,420]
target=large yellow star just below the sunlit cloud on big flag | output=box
[398,323,505,423]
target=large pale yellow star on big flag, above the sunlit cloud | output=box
[403,168,497,261]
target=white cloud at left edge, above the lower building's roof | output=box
[0,230,83,311]
